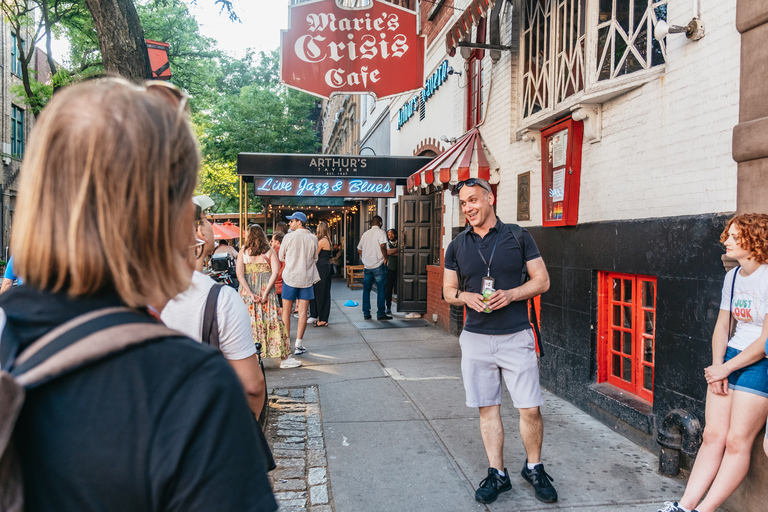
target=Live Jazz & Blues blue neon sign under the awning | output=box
[254,177,395,197]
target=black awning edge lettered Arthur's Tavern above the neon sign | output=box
[237,153,432,185]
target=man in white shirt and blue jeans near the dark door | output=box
[357,215,392,320]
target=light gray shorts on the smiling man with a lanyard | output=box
[459,329,544,409]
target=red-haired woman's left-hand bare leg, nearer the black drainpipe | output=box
[679,389,734,510]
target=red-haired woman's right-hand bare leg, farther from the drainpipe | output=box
[696,391,768,512]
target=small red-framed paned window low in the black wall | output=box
[597,272,657,403]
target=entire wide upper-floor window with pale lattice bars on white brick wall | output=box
[520,0,668,118]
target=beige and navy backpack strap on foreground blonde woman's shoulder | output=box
[11,308,182,388]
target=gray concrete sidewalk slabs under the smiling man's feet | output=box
[265,279,684,512]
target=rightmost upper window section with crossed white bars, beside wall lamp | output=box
[596,0,667,81]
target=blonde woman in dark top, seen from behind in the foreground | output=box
[0,78,277,512]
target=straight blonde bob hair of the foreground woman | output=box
[11,78,199,307]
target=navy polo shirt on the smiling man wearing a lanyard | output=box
[445,217,541,335]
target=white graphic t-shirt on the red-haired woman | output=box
[720,265,768,350]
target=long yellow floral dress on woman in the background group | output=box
[240,253,291,357]
